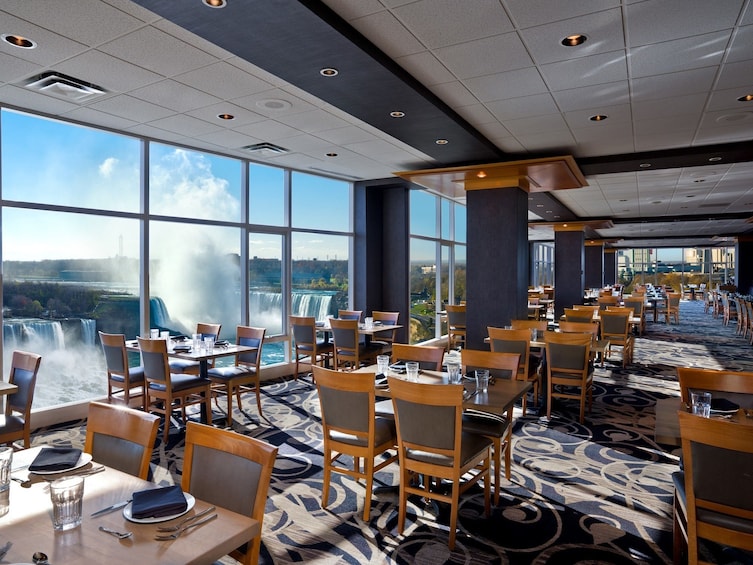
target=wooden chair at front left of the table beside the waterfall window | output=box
[137,337,212,442]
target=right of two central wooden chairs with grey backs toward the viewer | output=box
[388,377,491,550]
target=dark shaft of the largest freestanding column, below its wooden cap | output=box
[466,187,529,349]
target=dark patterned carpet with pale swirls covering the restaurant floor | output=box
[29,301,753,565]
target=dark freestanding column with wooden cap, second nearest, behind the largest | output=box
[554,224,585,320]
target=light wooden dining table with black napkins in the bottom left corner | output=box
[0,446,261,565]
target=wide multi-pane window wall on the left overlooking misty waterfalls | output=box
[0,109,352,409]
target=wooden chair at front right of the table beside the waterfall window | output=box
[208,326,267,426]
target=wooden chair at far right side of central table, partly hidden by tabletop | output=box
[461,348,525,505]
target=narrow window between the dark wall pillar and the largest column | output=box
[409,191,466,343]
